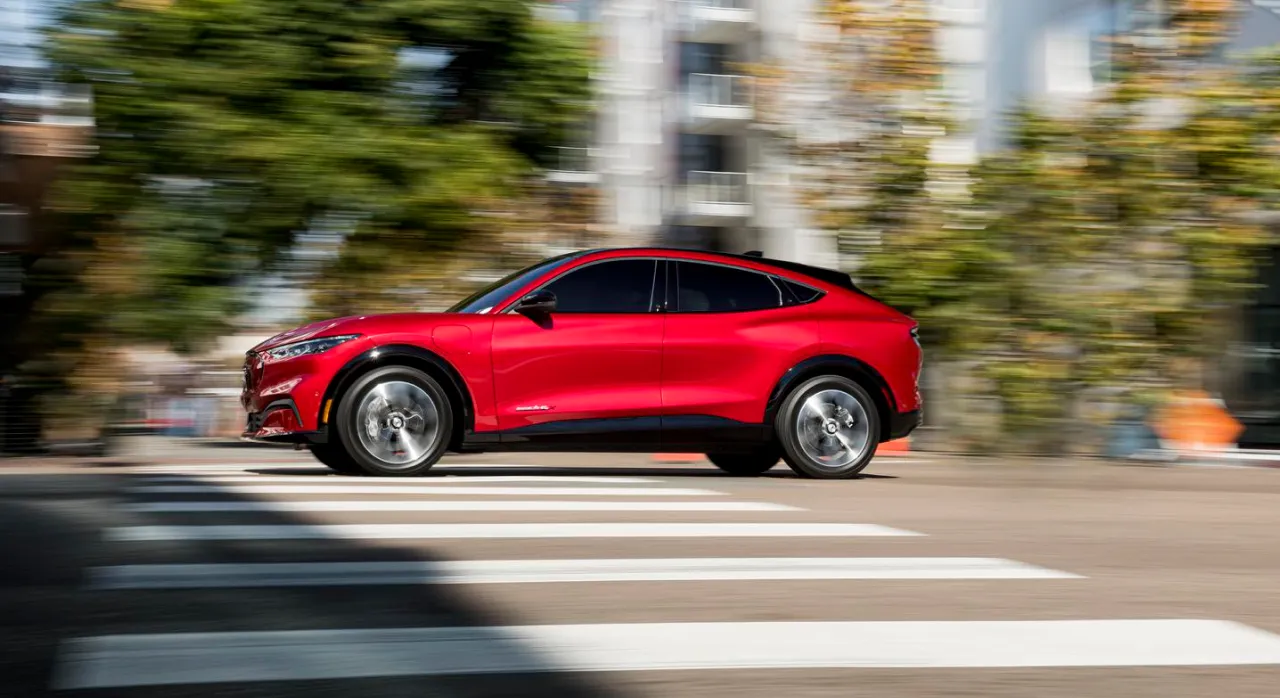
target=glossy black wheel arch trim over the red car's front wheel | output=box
[317,345,475,450]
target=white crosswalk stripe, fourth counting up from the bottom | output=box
[122,499,804,514]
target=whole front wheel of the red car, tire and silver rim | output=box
[334,366,453,478]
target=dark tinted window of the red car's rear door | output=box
[676,261,783,312]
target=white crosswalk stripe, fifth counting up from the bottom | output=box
[127,480,724,497]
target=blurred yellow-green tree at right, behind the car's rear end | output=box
[764,0,1280,453]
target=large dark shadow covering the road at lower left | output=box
[0,475,632,698]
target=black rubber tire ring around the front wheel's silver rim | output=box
[334,366,453,478]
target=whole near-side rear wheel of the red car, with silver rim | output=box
[774,375,882,480]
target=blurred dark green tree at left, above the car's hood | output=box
[28,0,591,435]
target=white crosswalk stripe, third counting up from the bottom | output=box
[105,523,923,542]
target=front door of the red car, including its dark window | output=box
[492,259,663,444]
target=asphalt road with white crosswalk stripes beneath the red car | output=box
[0,450,1280,698]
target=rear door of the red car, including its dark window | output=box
[662,260,819,447]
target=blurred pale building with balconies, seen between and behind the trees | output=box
[547,0,1280,265]
